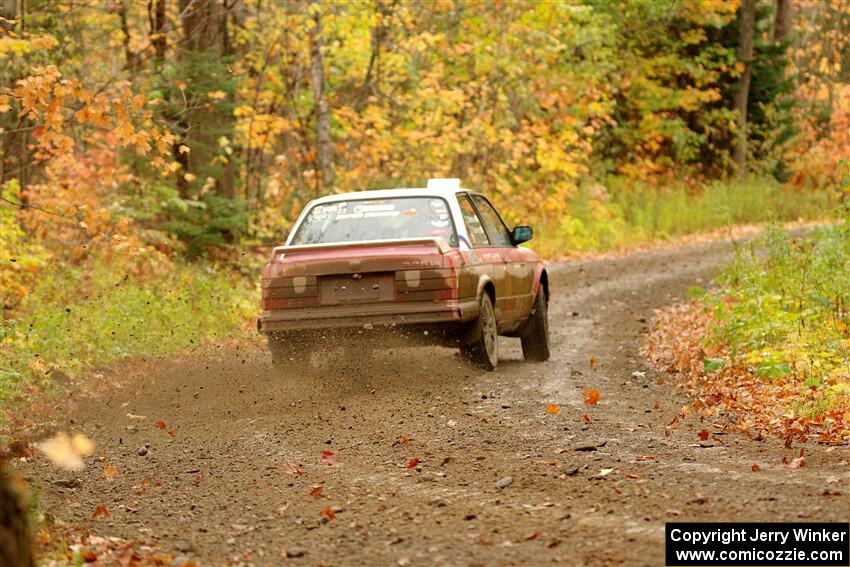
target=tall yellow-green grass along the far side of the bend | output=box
[532,178,837,258]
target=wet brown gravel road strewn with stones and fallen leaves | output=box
[25,239,850,565]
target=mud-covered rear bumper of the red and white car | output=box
[257,299,478,333]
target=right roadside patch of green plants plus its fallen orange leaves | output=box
[646,218,850,443]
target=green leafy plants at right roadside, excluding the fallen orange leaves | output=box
[706,218,850,418]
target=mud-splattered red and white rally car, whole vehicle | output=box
[257,180,549,369]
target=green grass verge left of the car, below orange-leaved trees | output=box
[0,257,256,441]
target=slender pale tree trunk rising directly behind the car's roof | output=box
[310,4,334,192]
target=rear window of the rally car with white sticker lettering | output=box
[291,197,457,245]
